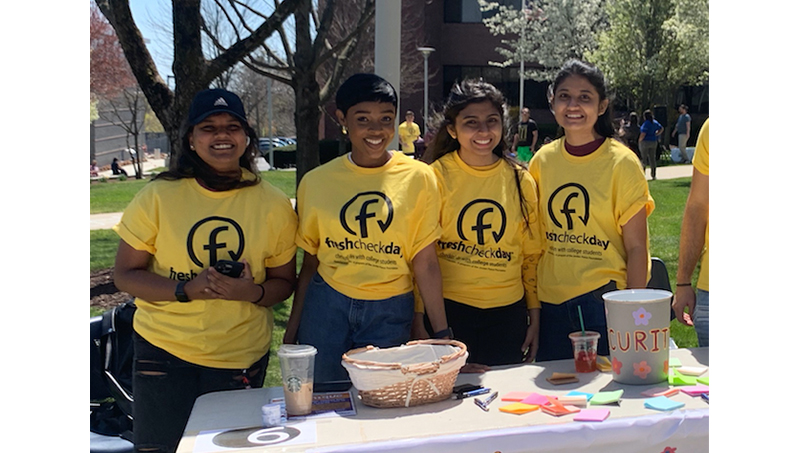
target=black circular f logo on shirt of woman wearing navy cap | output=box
[169,216,244,280]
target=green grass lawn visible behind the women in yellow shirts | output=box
[90,175,697,386]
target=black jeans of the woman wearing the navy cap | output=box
[133,332,269,453]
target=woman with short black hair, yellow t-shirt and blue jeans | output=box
[284,74,449,383]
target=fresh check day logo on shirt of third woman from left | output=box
[438,198,513,267]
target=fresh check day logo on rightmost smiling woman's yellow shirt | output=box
[545,183,610,256]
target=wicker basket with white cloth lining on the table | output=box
[342,340,468,407]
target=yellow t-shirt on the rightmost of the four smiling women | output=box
[530,138,655,304]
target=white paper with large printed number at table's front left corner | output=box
[192,420,317,453]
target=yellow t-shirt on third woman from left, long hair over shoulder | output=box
[431,152,542,308]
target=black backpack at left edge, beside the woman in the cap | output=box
[89,300,136,438]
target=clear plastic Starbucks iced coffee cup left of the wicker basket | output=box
[278,344,317,415]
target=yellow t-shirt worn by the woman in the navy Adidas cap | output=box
[114,173,297,368]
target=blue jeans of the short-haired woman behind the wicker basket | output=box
[297,274,414,383]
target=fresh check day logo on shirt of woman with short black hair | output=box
[323,191,403,269]
